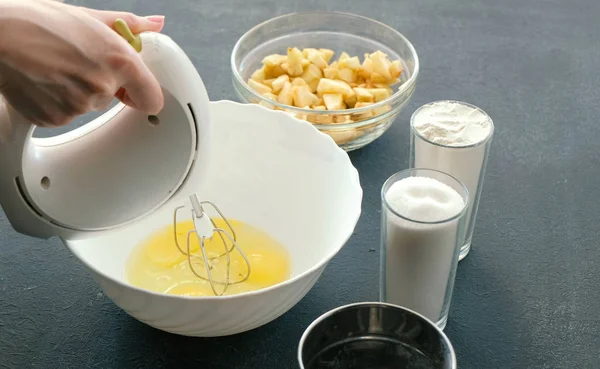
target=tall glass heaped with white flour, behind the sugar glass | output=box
[410,100,494,260]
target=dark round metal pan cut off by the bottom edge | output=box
[298,302,457,369]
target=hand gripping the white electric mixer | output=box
[0,0,164,127]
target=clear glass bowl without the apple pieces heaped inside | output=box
[231,12,419,151]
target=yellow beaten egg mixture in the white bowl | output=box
[126,219,291,296]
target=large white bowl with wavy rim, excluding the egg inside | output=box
[65,101,362,337]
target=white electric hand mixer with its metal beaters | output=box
[0,20,250,295]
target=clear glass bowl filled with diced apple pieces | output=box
[231,12,419,151]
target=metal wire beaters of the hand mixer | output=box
[173,194,250,296]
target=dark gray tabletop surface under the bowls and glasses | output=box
[0,0,600,369]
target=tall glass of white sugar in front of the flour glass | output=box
[380,169,469,329]
